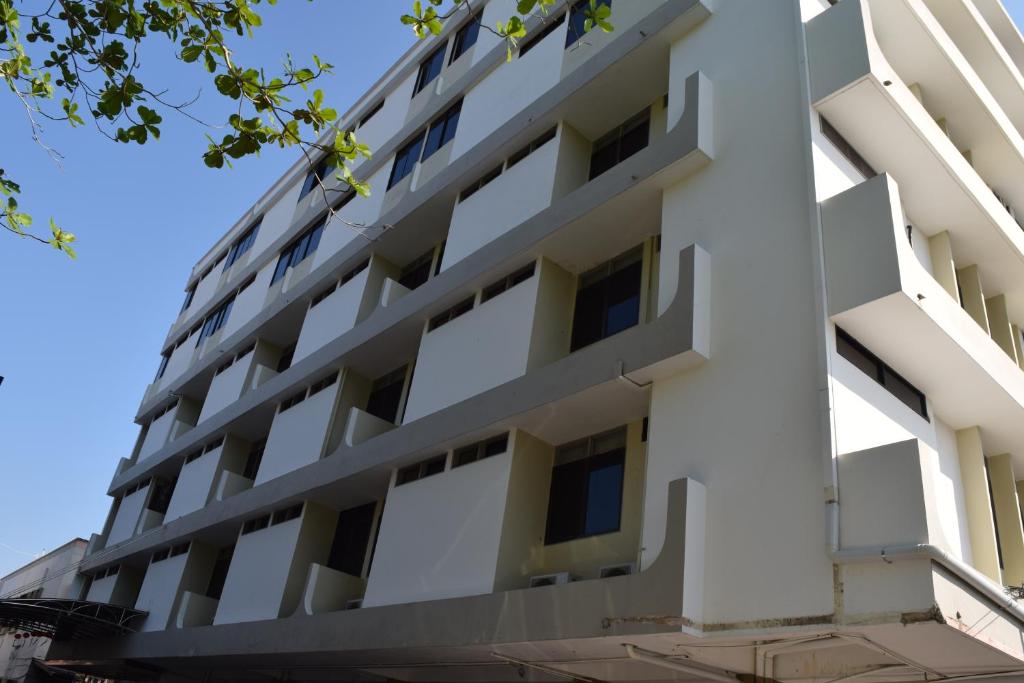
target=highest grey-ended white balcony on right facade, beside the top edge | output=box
[807,0,1024,319]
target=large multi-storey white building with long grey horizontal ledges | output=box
[37,0,1024,682]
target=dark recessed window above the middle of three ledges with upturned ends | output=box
[569,247,643,351]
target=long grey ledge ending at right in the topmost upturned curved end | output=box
[108,63,713,495]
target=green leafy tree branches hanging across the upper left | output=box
[0,0,612,258]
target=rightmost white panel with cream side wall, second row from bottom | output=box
[404,259,575,423]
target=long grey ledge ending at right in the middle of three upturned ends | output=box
[81,237,711,572]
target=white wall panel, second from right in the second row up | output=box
[256,379,342,485]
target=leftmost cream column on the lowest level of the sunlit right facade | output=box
[956,427,1002,583]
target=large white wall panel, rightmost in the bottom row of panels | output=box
[362,453,512,607]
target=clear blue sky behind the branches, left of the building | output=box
[0,0,1024,575]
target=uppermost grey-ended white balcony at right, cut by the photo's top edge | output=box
[806,0,1024,319]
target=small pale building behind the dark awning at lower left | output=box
[0,539,88,683]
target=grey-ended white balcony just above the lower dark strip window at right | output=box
[821,175,1024,471]
